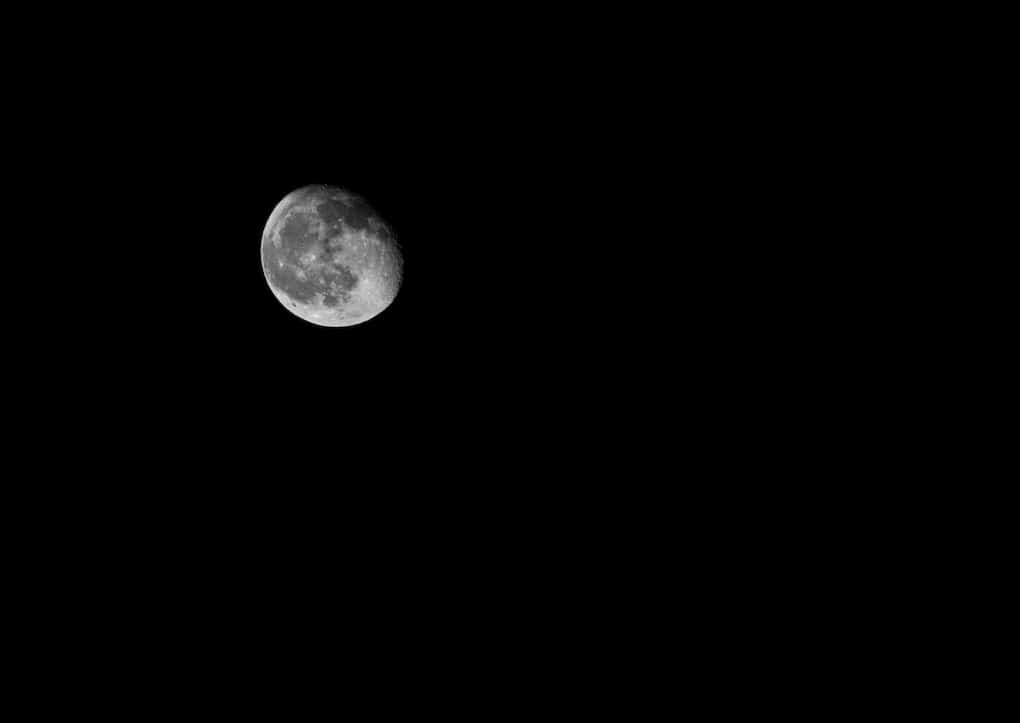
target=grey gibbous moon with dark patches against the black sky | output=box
[262,186,402,326]
